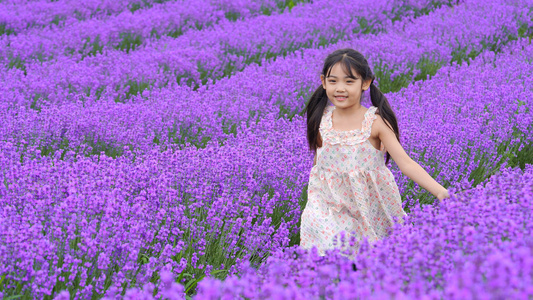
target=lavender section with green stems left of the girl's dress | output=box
[0,114,307,298]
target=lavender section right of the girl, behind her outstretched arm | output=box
[389,38,533,209]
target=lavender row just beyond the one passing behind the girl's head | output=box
[0,0,458,102]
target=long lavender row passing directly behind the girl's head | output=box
[0,1,532,164]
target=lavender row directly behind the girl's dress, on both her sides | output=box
[0,31,533,299]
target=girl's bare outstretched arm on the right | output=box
[372,117,449,200]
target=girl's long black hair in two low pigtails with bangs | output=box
[303,48,400,163]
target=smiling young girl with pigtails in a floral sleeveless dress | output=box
[300,49,449,255]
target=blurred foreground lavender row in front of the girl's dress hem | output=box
[186,165,533,300]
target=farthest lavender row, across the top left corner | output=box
[0,0,299,62]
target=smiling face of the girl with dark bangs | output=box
[320,63,372,108]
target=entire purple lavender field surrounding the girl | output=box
[0,0,533,300]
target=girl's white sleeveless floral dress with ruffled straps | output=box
[300,106,406,255]
